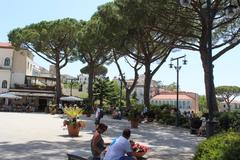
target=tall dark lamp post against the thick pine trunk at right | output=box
[180,0,240,137]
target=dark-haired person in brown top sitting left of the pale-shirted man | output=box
[91,123,108,160]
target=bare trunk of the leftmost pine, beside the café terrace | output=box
[55,54,62,107]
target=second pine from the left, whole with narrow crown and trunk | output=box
[76,14,111,105]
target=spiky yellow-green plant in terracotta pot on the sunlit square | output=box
[63,107,86,137]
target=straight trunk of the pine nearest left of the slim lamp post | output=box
[144,64,152,108]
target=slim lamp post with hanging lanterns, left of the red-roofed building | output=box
[169,55,187,127]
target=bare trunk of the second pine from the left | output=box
[88,63,94,107]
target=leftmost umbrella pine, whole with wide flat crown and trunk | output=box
[8,18,82,104]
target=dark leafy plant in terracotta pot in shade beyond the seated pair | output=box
[128,107,141,128]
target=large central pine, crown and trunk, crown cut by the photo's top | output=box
[97,0,188,106]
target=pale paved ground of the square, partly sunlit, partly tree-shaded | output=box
[0,112,204,160]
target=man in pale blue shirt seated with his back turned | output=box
[103,129,136,160]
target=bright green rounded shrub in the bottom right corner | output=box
[194,132,240,160]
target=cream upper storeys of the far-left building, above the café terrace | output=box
[0,43,33,93]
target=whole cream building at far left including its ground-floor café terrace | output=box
[0,43,56,111]
